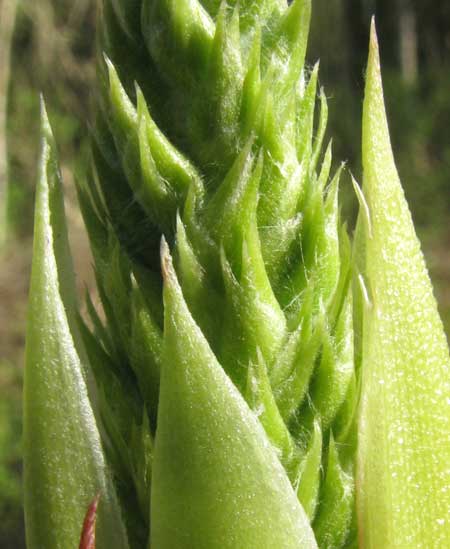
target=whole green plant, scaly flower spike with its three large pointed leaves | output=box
[25,0,450,549]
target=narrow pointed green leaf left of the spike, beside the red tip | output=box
[24,101,128,549]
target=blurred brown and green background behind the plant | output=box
[0,0,450,549]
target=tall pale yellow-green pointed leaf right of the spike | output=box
[357,20,450,549]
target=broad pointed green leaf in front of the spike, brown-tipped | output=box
[151,244,316,549]
